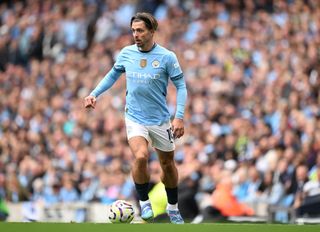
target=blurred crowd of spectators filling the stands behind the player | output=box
[0,0,320,222]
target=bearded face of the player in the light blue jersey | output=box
[131,21,153,50]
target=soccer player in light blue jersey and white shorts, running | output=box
[84,12,187,224]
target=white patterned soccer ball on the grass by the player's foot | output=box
[109,200,135,223]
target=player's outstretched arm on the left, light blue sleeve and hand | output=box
[84,67,122,108]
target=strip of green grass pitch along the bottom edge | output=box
[0,222,320,232]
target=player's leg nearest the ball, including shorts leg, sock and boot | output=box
[126,119,153,221]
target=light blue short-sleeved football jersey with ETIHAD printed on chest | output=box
[114,44,183,125]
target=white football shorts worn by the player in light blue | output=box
[125,118,175,151]
